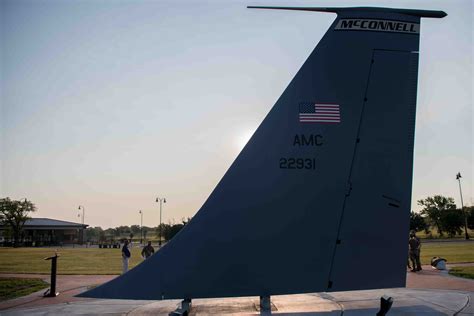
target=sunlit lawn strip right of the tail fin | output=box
[421,241,474,264]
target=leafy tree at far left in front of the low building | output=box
[0,197,36,247]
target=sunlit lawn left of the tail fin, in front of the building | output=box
[0,247,143,274]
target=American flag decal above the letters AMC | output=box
[299,102,341,123]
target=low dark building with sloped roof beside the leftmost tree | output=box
[0,218,89,247]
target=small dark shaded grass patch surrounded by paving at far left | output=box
[0,278,49,301]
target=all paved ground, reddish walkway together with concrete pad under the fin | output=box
[0,263,474,316]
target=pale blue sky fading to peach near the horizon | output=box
[0,0,474,228]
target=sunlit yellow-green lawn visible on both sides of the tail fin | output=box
[0,241,474,274]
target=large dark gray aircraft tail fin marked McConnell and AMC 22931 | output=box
[81,8,445,299]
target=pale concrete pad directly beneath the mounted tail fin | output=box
[1,288,474,316]
